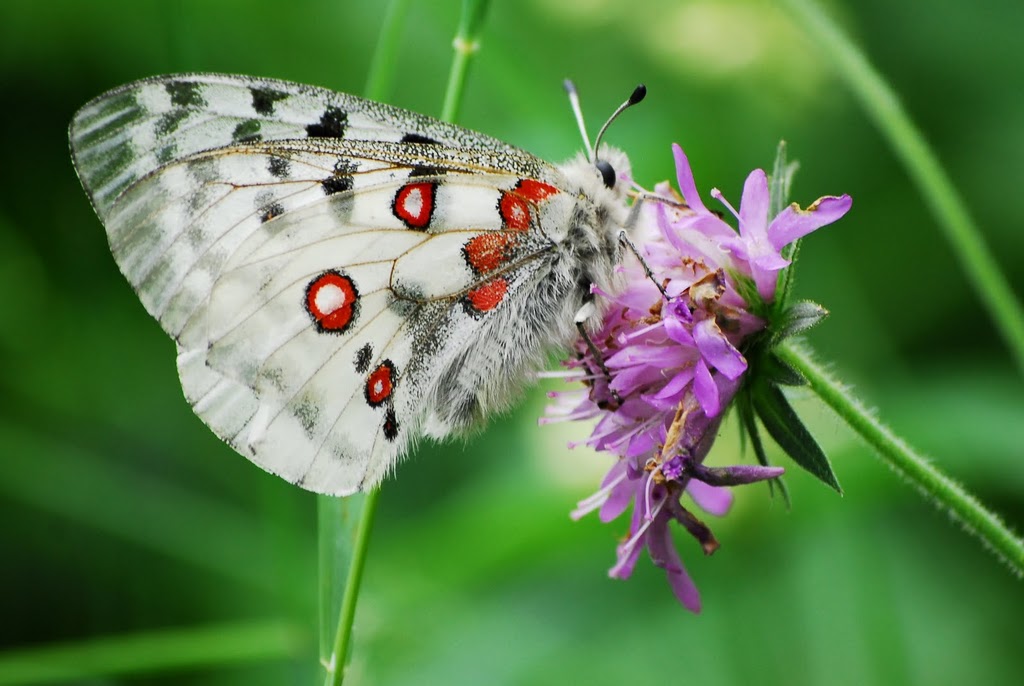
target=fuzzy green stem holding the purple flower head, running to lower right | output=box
[776,345,1024,576]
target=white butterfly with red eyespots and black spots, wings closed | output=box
[70,74,643,495]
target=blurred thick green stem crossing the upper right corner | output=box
[785,0,1024,373]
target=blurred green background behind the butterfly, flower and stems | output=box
[0,0,1024,685]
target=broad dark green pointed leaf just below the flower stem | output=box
[751,379,843,494]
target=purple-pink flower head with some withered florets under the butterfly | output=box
[541,145,851,611]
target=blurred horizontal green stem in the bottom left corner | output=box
[0,619,311,686]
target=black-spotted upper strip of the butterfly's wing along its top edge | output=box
[71,74,518,218]
